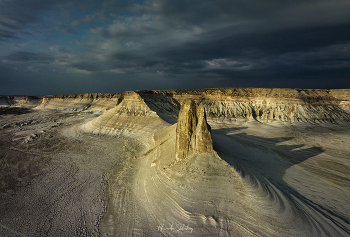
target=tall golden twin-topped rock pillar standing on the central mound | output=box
[175,100,214,161]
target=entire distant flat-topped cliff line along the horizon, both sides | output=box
[0,88,350,123]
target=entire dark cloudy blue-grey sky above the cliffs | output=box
[0,0,350,95]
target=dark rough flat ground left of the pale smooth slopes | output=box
[0,110,128,236]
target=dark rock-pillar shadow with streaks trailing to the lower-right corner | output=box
[213,127,350,234]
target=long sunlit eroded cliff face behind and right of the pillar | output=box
[167,88,350,123]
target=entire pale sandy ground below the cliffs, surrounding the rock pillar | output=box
[0,106,350,236]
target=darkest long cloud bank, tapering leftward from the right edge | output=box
[160,24,350,66]
